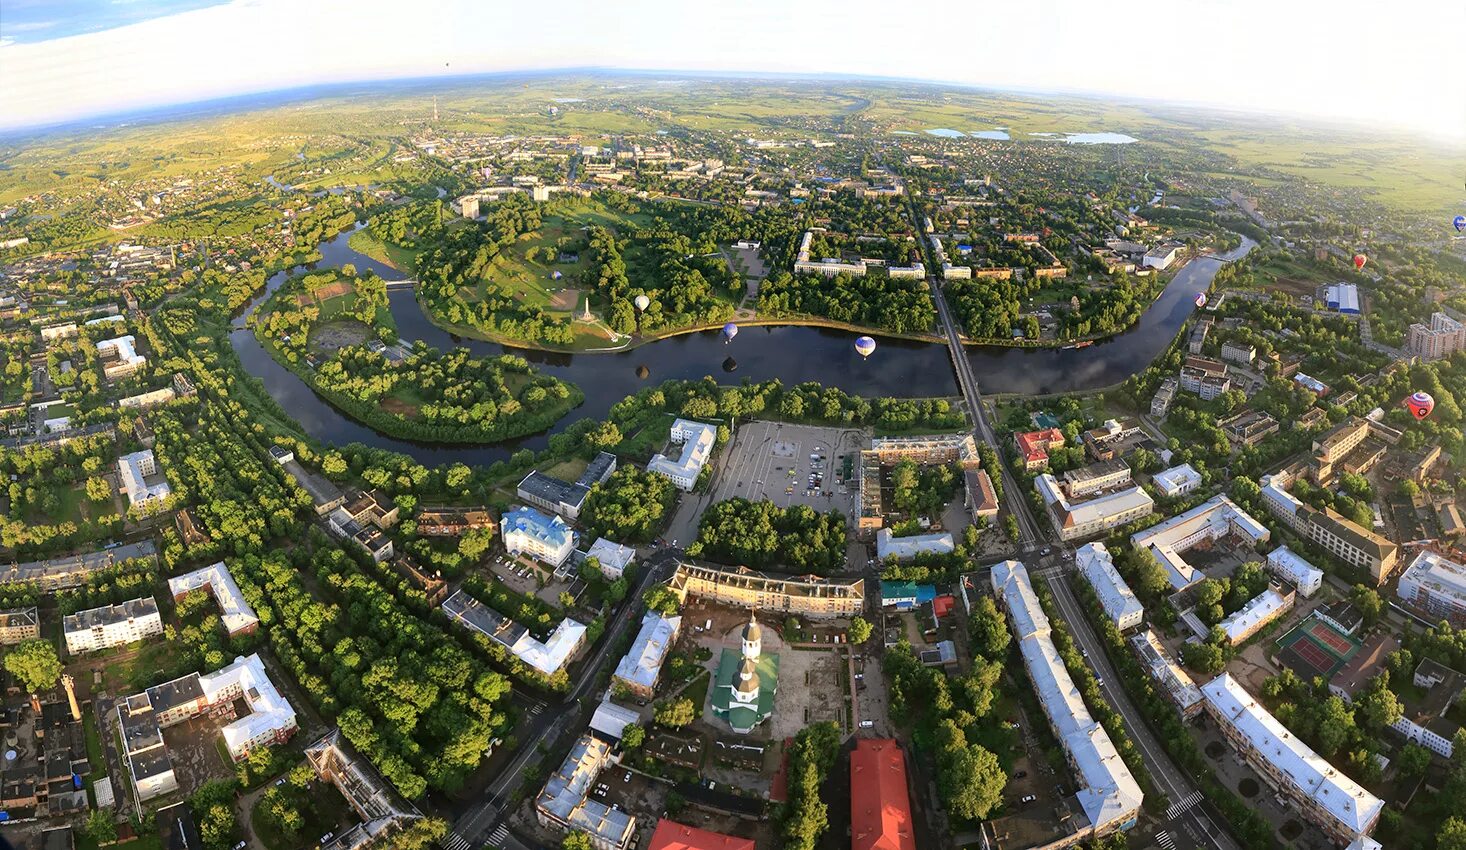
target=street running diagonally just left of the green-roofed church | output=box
[441,548,682,850]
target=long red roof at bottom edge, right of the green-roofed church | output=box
[850,739,916,850]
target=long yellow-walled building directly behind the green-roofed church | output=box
[667,561,865,618]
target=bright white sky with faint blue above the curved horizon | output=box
[0,0,1466,139]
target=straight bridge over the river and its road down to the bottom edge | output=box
[927,276,1237,850]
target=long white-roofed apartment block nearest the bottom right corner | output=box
[1201,673,1384,849]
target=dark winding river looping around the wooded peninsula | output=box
[230,225,1255,466]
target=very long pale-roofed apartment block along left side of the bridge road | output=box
[991,561,1145,840]
